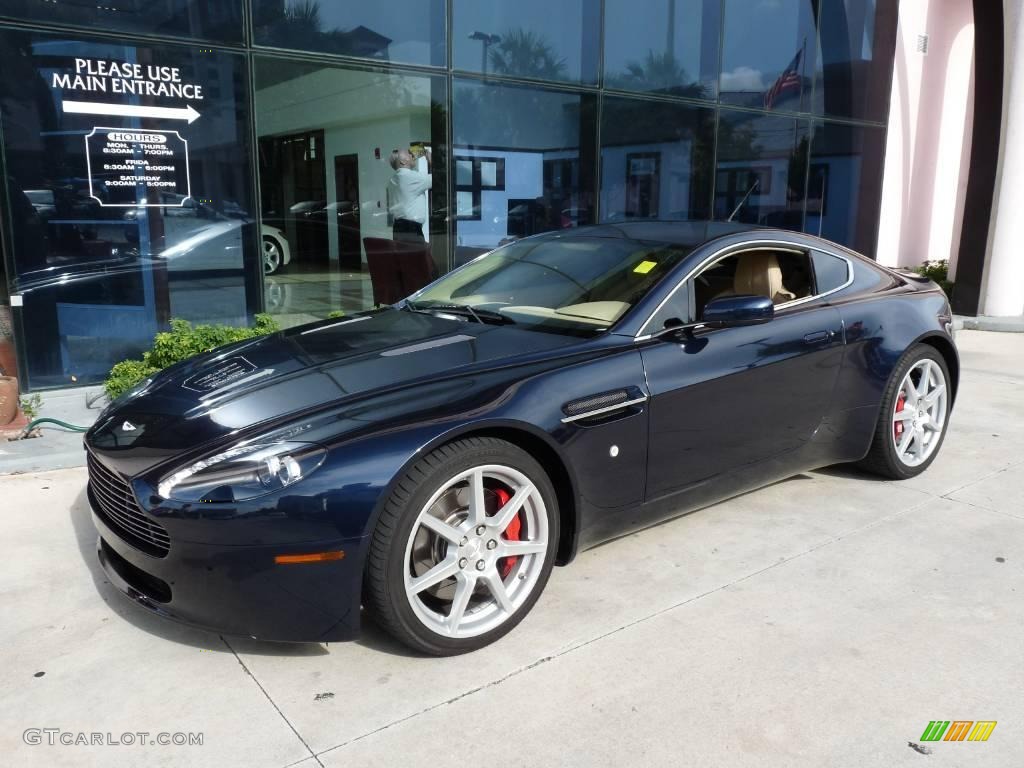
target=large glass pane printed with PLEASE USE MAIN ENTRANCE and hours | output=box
[0,31,259,388]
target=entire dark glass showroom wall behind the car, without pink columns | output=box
[0,0,898,388]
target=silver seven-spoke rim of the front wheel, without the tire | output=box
[403,464,548,638]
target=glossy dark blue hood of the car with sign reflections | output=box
[86,309,581,473]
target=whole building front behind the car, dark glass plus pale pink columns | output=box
[0,0,1024,389]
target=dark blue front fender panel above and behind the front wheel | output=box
[303,346,647,562]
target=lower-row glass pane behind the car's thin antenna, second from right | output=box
[715,110,808,230]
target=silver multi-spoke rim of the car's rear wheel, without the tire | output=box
[891,357,948,467]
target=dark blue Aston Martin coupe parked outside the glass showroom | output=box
[86,222,959,654]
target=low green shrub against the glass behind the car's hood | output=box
[103,314,281,400]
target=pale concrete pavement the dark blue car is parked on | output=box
[0,332,1024,768]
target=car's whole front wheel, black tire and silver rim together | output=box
[365,437,558,655]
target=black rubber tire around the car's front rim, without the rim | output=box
[364,437,559,656]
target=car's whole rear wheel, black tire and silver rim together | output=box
[861,344,952,480]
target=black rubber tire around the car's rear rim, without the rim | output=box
[858,344,952,480]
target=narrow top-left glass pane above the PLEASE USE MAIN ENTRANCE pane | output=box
[0,0,243,43]
